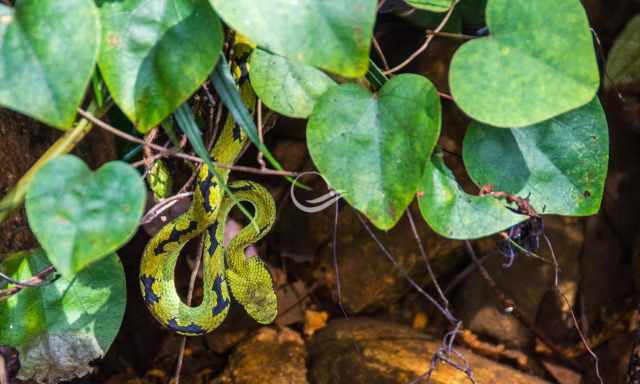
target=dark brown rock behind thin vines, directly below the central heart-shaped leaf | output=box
[311,202,463,313]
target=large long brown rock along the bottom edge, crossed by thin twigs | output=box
[309,318,546,384]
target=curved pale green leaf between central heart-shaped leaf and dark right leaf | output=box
[418,153,527,239]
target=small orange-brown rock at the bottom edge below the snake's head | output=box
[213,327,307,384]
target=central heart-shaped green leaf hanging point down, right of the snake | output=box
[307,74,441,230]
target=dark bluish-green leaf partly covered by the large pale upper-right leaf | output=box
[463,98,609,216]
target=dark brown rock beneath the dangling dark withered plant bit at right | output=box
[454,216,584,348]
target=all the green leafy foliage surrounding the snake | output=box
[0,0,612,379]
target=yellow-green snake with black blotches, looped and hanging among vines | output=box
[140,42,277,335]
